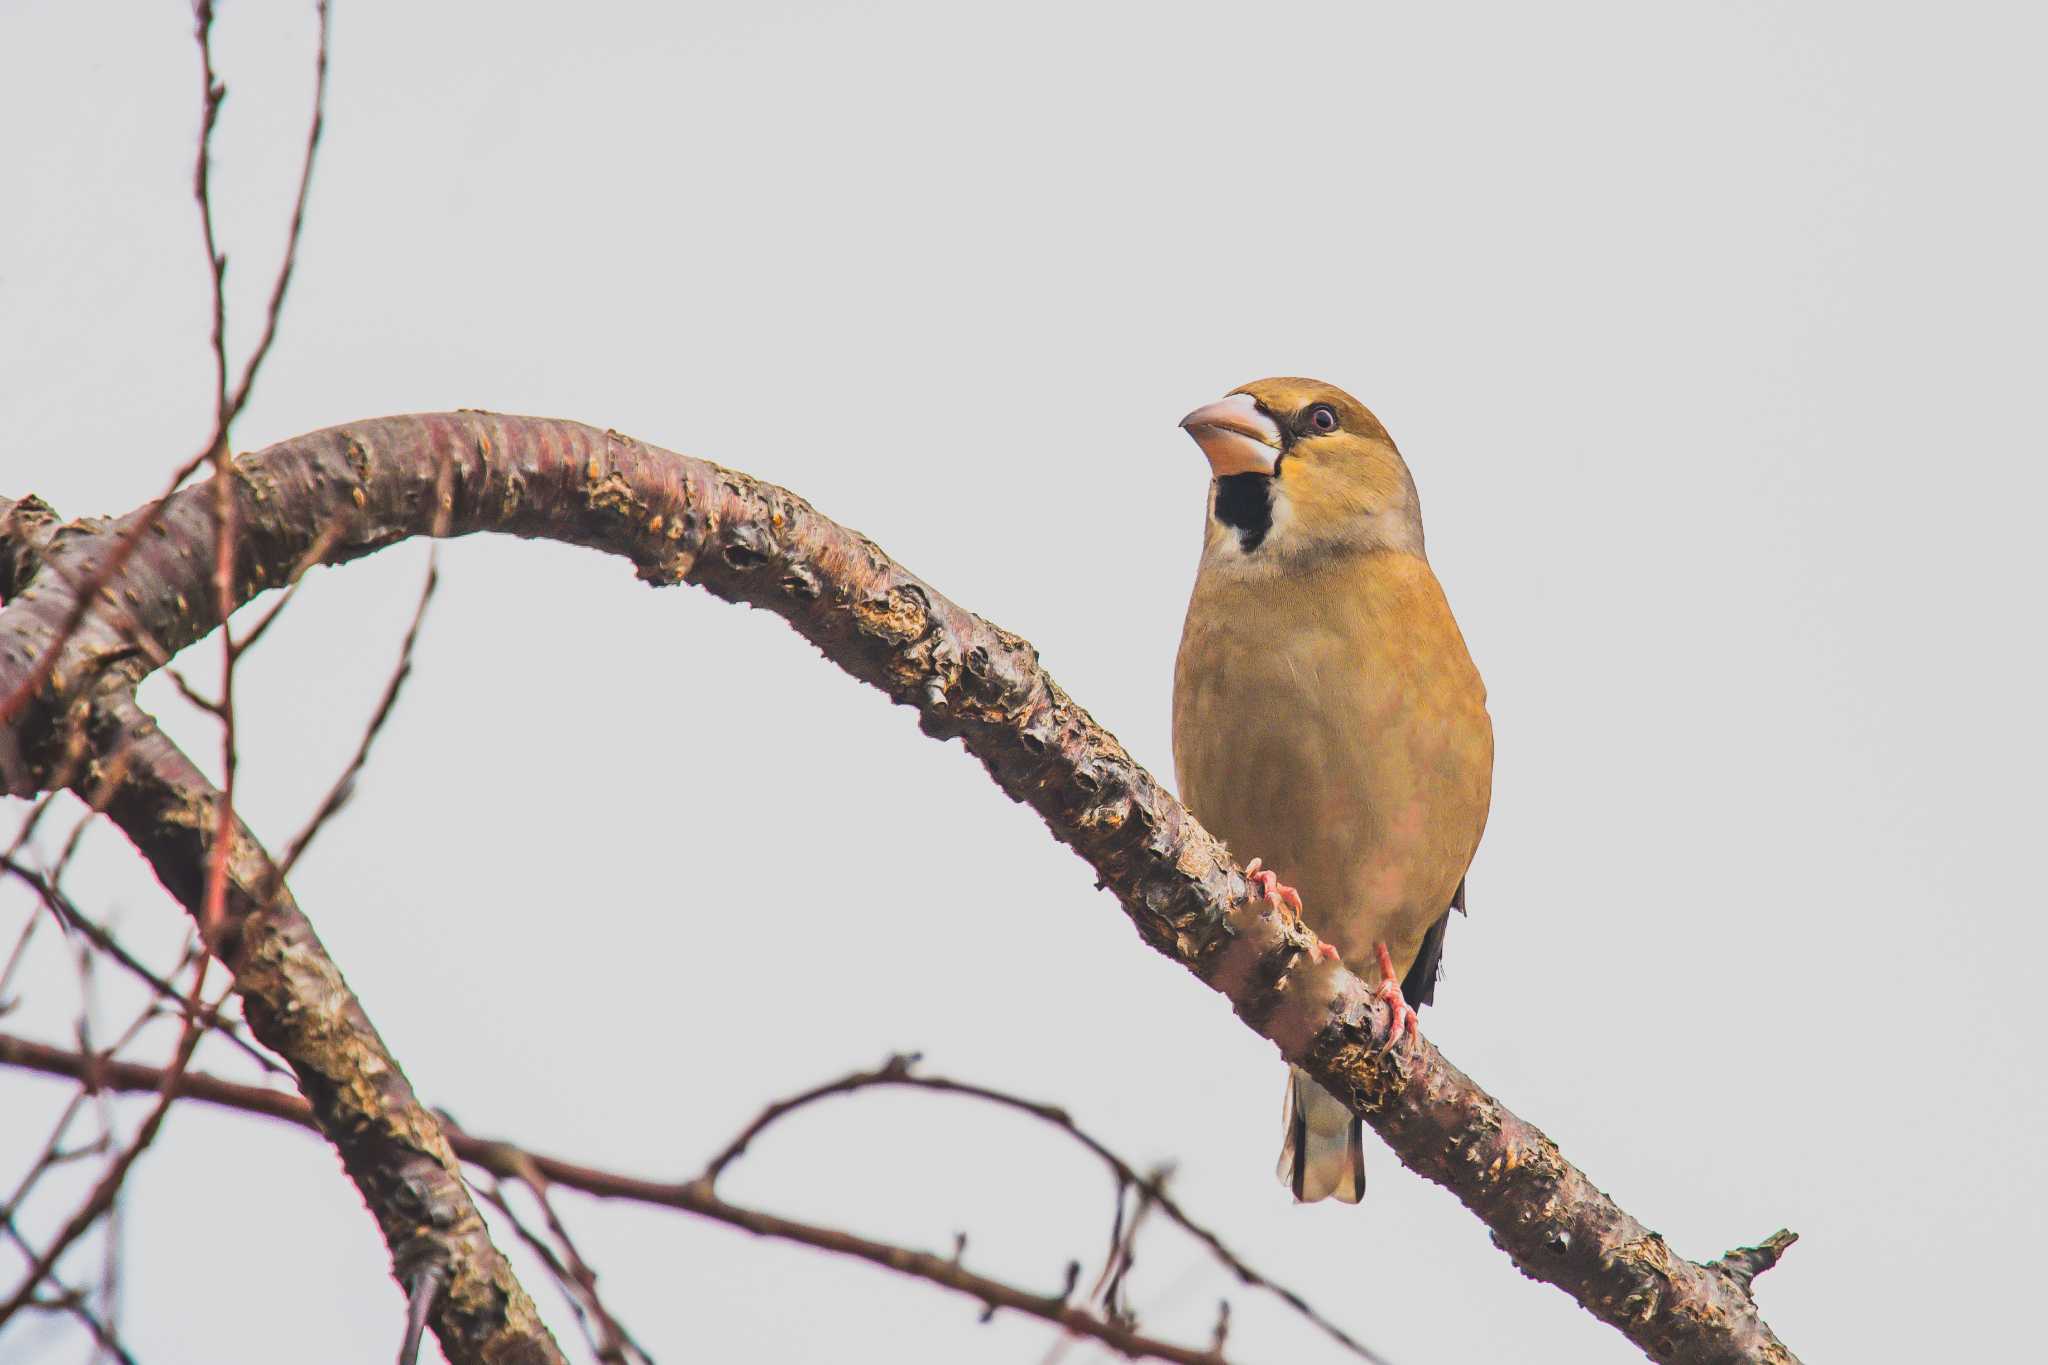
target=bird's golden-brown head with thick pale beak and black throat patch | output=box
[1180,379,1421,567]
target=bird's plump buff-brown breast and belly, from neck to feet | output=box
[1174,555,1493,972]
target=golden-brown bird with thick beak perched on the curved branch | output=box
[1174,379,1493,1203]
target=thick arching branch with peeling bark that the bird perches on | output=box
[0,413,1794,1365]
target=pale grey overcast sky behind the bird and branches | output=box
[0,0,2048,1365]
